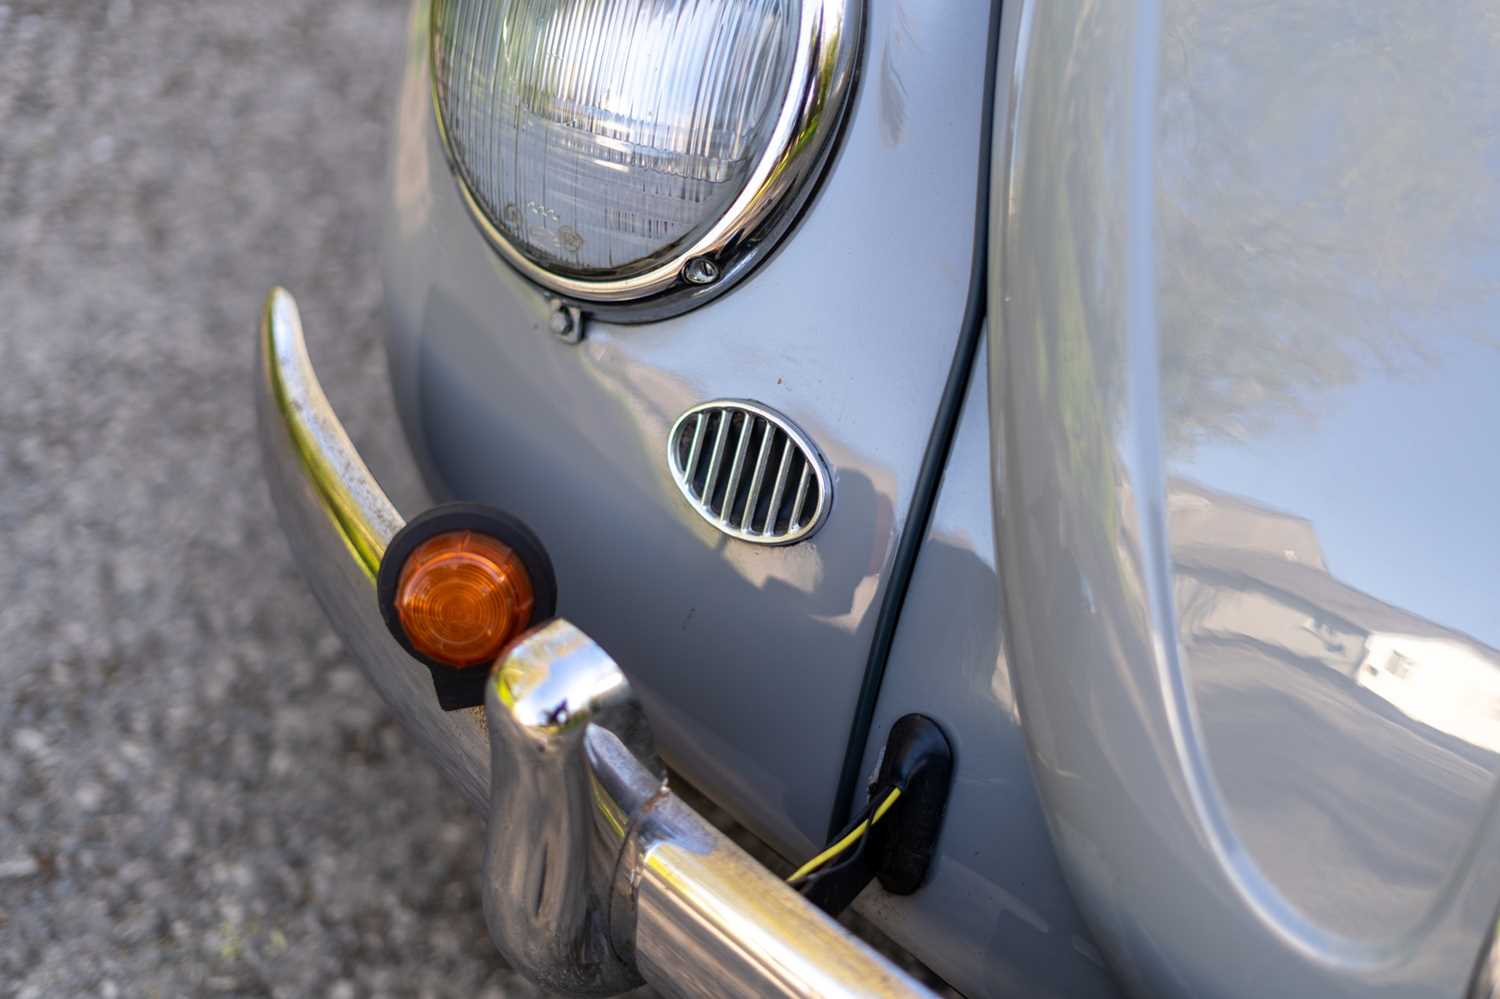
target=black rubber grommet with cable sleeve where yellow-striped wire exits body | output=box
[801,714,953,915]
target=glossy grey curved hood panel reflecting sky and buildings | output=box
[990,0,1500,996]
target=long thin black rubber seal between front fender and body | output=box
[828,0,1002,840]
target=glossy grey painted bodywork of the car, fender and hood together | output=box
[375,0,1500,996]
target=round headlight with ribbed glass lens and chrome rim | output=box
[432,0,864,305]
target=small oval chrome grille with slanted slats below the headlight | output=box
[668,402,830,545]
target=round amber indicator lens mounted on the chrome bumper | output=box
[395,531,533,668]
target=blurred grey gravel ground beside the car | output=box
[0,0,561,996]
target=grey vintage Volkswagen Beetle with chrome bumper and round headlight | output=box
[258,0,1500,998]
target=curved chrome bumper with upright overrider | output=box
[257,290,930,996]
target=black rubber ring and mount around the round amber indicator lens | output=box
[375,503,558,711]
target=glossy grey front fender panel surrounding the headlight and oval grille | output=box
[386,0,989,857]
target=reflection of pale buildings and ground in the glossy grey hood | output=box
[1167,480,1500,935]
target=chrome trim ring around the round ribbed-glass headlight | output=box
[425,0,866,308]
